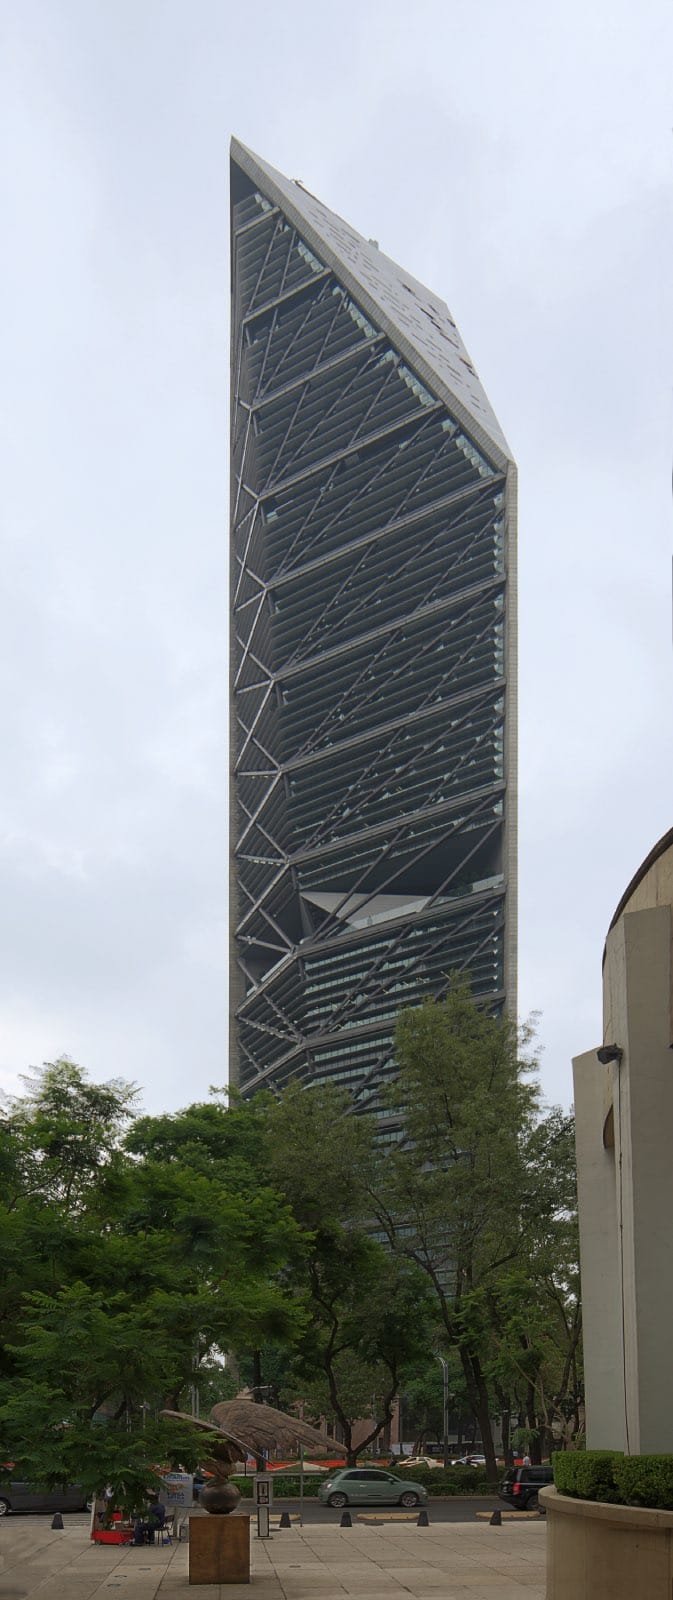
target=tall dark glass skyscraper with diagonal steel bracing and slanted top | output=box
[232,146,515,1106]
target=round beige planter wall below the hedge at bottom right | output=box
[540,1488,673,1600]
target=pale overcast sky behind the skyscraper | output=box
[0,0,673,1110]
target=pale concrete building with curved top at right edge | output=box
[574,830,673,1454]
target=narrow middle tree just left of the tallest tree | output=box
[267,1085,428,1462]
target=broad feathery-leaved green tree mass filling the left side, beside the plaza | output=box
[0,1062,304,1482]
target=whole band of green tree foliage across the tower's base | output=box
[0,1004,582,1498]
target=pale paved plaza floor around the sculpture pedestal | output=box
[0,1517,545,1600]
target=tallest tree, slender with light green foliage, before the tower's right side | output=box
[369,982,539,1482]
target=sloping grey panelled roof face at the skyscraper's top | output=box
[232,139,512,469]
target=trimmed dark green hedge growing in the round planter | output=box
[552,1450,673,1510]
